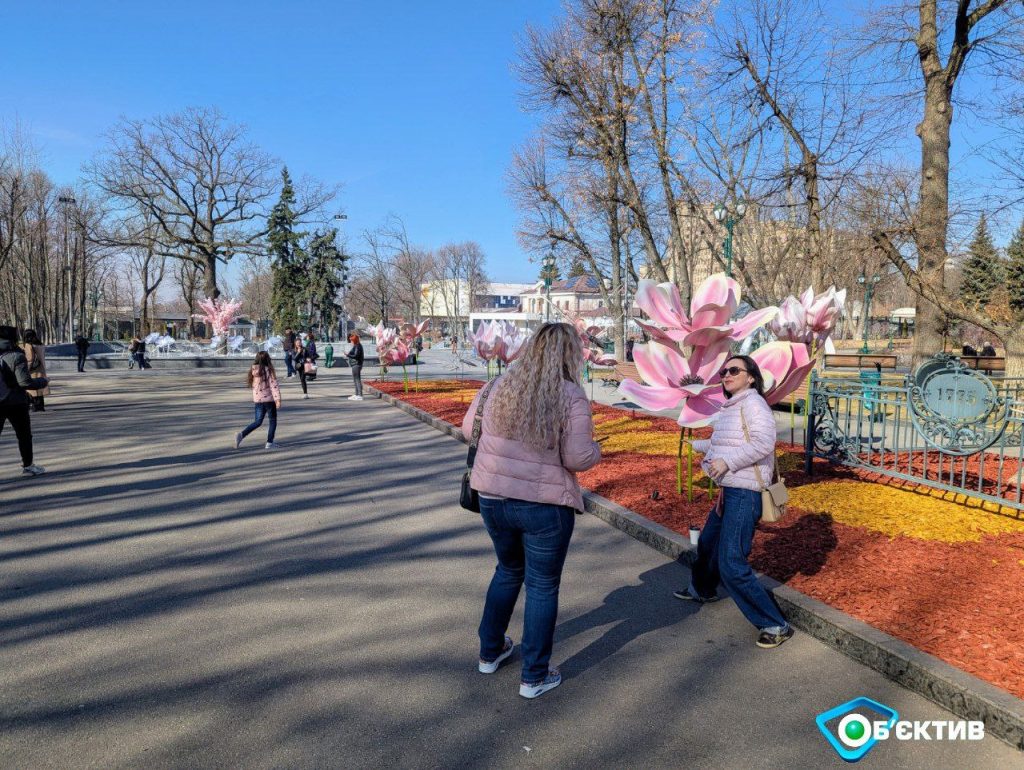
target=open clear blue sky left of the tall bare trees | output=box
[0,0,559,281]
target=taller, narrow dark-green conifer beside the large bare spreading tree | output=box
[266,168,308,334]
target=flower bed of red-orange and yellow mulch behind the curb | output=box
[371,380,1024,697]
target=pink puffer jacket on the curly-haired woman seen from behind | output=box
[462,381,601,511]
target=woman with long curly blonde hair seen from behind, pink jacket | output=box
[462,324,601,698]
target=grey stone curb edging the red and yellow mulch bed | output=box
[364,385,1024,751]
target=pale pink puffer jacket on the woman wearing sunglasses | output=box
[693,390,776,490]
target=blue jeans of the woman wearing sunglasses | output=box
[691,486,788,629]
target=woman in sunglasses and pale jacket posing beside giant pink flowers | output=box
[675,355,793,648]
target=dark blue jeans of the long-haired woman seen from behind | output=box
[480,498,575,684]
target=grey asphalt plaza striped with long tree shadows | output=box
[0,370,1024,768]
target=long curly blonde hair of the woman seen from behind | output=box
[492,324,583,448]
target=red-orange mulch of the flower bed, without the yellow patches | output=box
[371,380,1024,697]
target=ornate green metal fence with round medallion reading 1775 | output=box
[805,355,1024,510]
